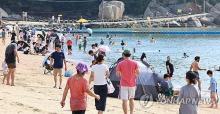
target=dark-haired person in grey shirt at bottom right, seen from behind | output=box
[178,71,200,114]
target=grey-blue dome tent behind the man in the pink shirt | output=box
[109,59,163,100]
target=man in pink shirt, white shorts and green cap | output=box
[116,50,139,114]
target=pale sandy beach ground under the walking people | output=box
[0,39,220,114]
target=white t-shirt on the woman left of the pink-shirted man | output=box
[92,64,109,85]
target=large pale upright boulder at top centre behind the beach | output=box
[99,1,125,20]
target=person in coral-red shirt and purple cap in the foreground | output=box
[60,63,100,114]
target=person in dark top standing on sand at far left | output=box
[5,42,19,86]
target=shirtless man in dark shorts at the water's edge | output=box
[190,56,206,91]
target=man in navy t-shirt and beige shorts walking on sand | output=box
[50,45,67,89]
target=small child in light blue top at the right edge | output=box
[207,70,218,108]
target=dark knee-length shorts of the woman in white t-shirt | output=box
[94,84,108,111]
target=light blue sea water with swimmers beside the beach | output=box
[64,28,220,96]
